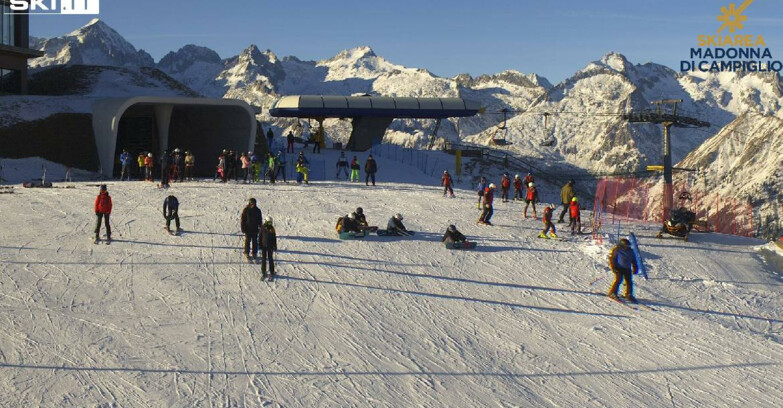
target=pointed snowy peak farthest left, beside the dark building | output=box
[30,18,155,68]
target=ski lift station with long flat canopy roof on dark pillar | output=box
[269,95,481,151]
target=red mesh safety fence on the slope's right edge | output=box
[593,178,754,237]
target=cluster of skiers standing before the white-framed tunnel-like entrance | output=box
[119,148,196,186]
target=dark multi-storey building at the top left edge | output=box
[0,0,43,95]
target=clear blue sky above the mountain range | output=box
[30,0,783,83]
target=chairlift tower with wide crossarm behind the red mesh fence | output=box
[623,99,711,220]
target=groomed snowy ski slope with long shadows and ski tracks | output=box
[0,154,783,407]
